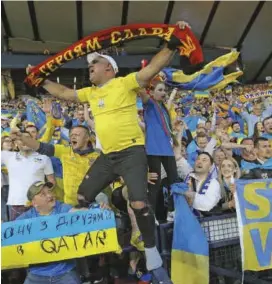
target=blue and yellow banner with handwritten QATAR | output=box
[1,208,118,270]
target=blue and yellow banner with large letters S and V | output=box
[235,179,272,271]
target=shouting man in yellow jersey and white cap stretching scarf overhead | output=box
[27,22,190,284]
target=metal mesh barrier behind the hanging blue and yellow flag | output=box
[159,213,271,284]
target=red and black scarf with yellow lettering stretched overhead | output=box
[25,24,203,87]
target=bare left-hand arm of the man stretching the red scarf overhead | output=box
[26,65,79,102]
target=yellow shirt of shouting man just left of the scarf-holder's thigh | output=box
[54,145,99,205]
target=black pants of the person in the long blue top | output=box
[147,155,178,215]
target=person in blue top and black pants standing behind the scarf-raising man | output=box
[141,84,178,215]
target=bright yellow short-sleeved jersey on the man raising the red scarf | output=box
[77,73,144,154]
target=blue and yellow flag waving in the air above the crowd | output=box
[163,51,243,90]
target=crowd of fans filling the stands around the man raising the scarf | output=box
[1,67,272,283]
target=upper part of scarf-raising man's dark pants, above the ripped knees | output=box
[78,146,148,202]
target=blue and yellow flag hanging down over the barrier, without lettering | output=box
[171,183,209,284]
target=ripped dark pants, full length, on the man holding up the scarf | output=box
[78,146,155,248]
